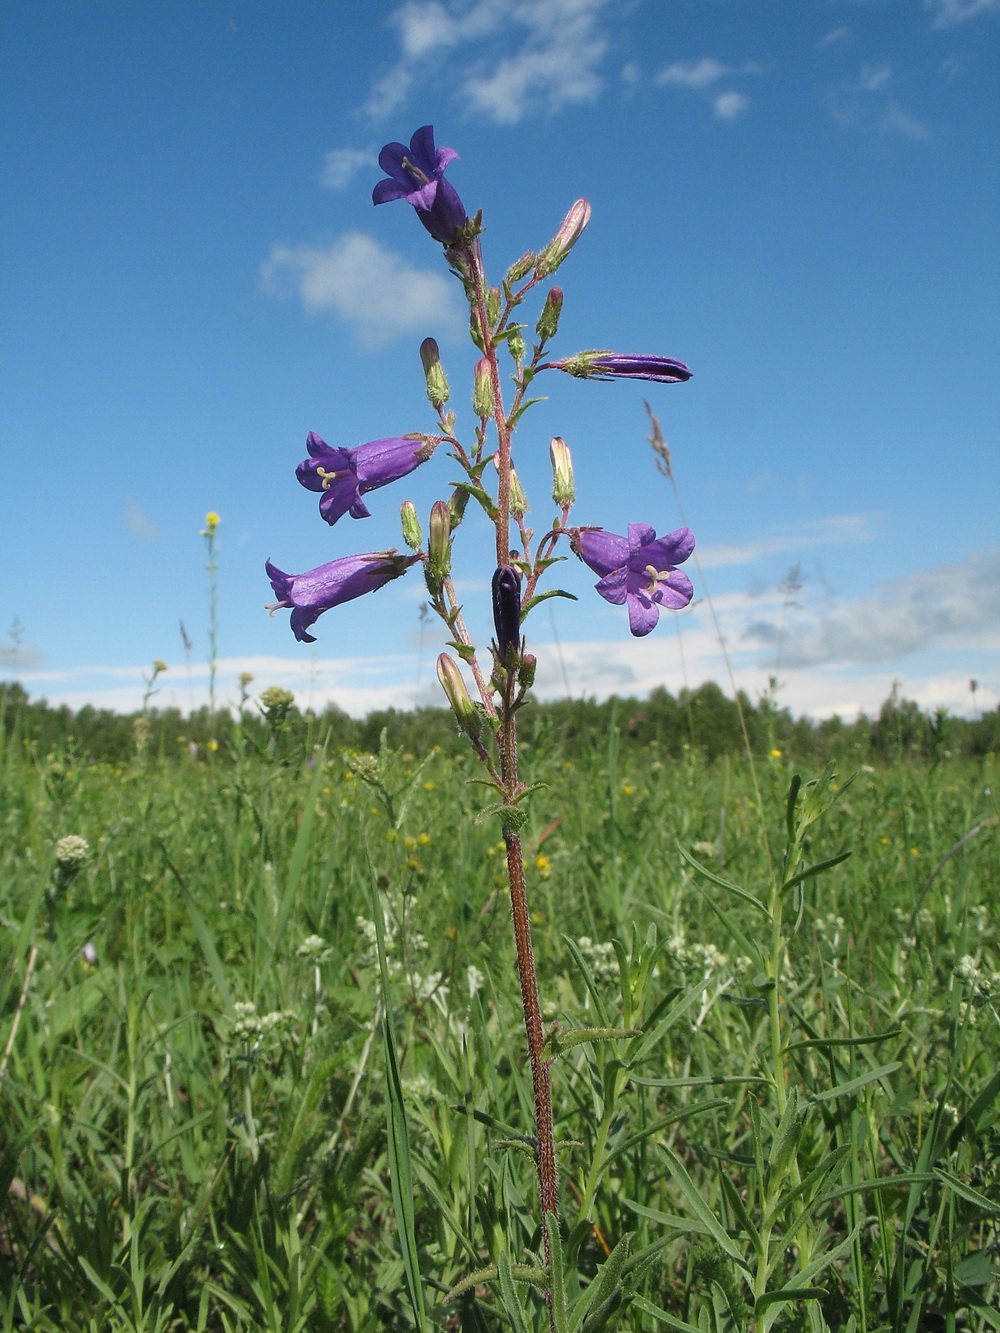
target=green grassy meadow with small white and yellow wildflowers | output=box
[0,700,1000,1333]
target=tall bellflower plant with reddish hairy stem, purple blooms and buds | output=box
[267,125,695,1328]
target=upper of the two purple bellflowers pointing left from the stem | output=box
[295,431,440,524]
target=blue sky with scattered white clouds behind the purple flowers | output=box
[0,0,1000,716]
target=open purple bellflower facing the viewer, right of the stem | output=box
[572,523,695,639]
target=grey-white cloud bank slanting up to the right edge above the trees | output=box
[747,547,1000,667]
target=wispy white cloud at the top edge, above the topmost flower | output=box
[363,0,611,125]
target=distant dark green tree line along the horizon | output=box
[0,681,1000,764]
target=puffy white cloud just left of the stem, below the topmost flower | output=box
[260,232,460,347]
